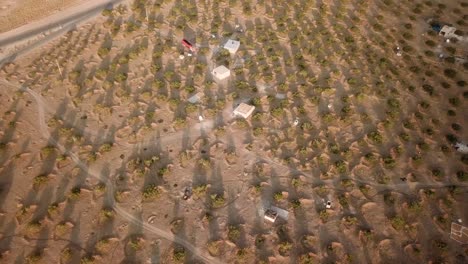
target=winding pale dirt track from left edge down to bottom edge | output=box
[2,81,221,263]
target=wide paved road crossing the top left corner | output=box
[0,0,124,67]
